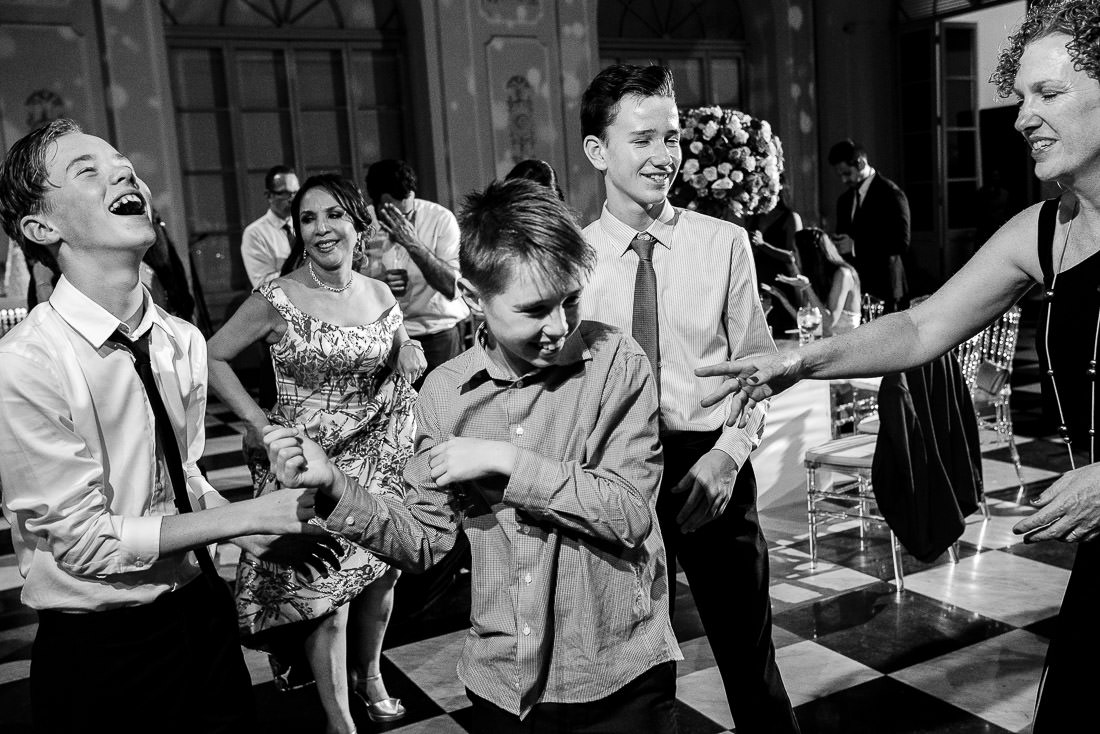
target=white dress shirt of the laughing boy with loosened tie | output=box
[0,276,215,611]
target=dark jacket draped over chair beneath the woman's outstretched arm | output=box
[871,352,982,561]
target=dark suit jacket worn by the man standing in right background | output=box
[836,173,910,310]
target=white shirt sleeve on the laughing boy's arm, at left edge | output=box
[0,353,161,577]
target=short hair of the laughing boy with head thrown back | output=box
[0,118,84,260]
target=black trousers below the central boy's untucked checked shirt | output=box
[466,662,678,734]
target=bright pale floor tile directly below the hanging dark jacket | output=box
[905,550,1069,626]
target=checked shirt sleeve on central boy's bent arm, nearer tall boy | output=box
[504,353,663,548]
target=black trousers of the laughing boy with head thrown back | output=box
[31,574,256,734]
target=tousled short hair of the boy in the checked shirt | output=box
[459,178,596,297]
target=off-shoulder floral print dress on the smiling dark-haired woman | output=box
[237,283,416,653]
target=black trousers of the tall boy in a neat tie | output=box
[657,431,799,734]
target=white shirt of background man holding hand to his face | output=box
[370,199,470,339]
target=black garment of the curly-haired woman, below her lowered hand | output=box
[1032,540,1100,734]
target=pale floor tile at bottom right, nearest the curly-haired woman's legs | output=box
[892,629,1047,732]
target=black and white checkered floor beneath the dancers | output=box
[0,294,1074,734]
